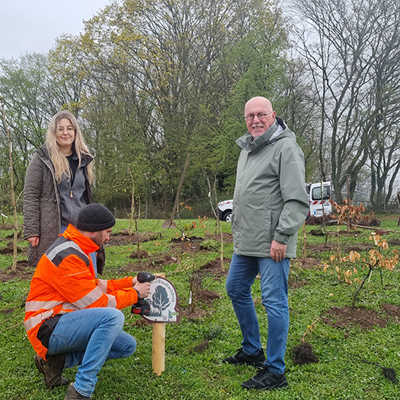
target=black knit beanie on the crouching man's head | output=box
[76,203,115,232]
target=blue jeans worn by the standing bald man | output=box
[226,254,290,374]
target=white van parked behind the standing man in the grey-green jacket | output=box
[217,182,332,222]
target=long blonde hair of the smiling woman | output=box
[45,110,94,184]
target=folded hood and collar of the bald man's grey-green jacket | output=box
[236,117,296,153]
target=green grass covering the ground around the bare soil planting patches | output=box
[0,216,400,400]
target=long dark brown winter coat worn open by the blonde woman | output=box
[23,147,90,265]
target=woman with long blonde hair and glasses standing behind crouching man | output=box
[24,111,96,270]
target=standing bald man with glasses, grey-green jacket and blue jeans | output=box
[224,97,308,390]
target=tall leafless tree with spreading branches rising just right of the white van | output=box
[294,0,398,201]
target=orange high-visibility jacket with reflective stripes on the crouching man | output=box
[24,225,138,359]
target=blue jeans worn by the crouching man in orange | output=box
[48,308,136,397]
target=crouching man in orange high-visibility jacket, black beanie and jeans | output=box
[24,203,150,400]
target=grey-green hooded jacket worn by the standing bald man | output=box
[232,118,309,258]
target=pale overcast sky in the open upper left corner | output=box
[0,0,112,59]
